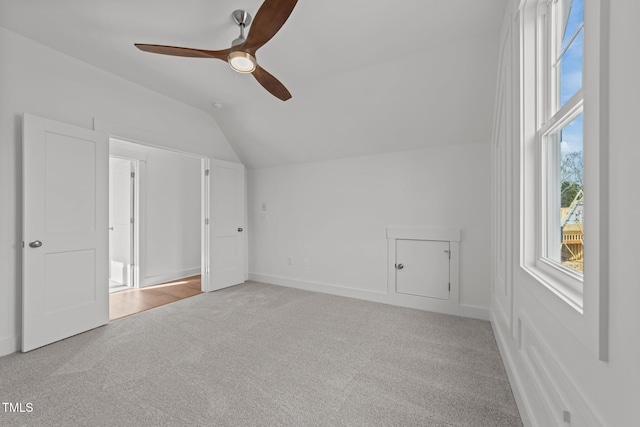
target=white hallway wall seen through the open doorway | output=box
[110,139,202,286]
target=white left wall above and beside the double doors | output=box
[0,28,238,354]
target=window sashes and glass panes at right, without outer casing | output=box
[536,0,588,293]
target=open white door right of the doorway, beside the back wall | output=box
[208,160,245,291]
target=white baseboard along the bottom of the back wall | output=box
[249,273,489,320]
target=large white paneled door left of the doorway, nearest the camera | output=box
[22,115,109,352]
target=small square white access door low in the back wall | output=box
[396,240,450,300]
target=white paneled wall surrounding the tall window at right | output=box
[492,0,640,427]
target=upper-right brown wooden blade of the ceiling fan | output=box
[243,0,298,52]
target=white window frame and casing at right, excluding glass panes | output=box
[516,0,609,361]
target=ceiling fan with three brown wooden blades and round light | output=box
[135,0,298,101]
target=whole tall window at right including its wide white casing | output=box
[516,0,610,360]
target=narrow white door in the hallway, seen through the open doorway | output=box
[109,157,133,287]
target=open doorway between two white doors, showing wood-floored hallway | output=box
[109,138,206,320]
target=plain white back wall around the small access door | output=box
[248,144,490,316]
